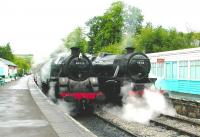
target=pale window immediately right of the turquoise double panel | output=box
[179,61,188,79]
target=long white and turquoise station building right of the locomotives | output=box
[147,47,200,95]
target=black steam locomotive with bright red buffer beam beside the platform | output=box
[38,47,105,113]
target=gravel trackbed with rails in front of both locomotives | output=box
[55,99,200,137]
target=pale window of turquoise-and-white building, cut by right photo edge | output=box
[190,60,200,80]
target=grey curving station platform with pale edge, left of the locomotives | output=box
[0,76,95,137]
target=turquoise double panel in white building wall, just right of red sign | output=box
[165,62,177,79]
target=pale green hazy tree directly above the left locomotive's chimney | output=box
[63,27,87,53]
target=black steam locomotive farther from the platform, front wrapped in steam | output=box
[93,48,151,103]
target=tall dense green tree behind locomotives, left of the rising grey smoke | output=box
[86,1,123,53]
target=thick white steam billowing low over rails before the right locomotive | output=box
[103,83,176,124]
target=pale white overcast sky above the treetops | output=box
[0,0,200,56]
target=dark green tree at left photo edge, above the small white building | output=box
[0,43,14,61]
